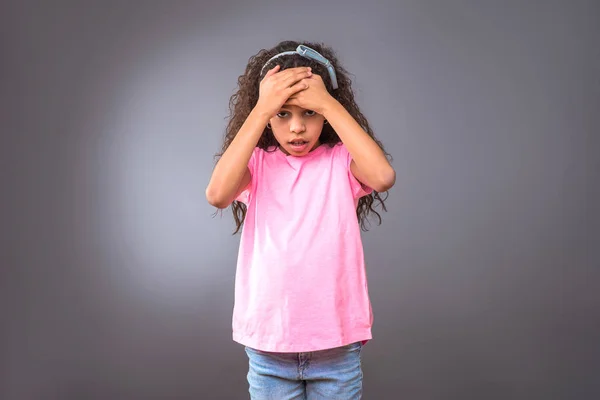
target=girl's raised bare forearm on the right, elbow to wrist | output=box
[323,99,396,192]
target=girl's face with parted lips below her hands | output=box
[270,106,325,157]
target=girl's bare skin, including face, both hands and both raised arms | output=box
[206,65,396,208]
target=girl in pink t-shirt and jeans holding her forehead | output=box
[206,41,395,400]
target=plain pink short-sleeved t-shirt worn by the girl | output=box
[232,143,373,352]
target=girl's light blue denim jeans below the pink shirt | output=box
[246,342,363,400]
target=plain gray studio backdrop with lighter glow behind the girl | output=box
[0,0,600,400]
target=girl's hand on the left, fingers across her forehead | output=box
[256,65,312,117]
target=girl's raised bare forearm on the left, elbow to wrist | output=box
[206,104,269,208]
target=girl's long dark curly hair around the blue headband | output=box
[215,41,392,234]
